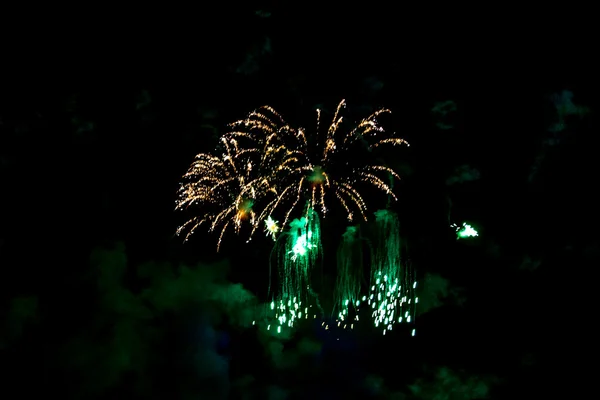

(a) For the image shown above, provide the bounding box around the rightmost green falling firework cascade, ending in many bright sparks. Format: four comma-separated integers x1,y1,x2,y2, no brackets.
367,210,419,336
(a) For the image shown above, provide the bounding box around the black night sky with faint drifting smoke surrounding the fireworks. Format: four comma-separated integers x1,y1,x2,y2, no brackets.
0,1,600,399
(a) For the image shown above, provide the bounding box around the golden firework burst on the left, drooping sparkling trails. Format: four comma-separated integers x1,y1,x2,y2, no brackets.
176,107,287,251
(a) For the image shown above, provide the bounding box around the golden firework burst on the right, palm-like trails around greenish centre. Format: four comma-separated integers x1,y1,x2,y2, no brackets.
255,100,408,233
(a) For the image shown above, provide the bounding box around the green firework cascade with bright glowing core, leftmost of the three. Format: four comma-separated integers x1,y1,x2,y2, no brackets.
267,207,321,333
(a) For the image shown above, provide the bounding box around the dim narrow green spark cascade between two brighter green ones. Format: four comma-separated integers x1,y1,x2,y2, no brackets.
335,226,366,329
